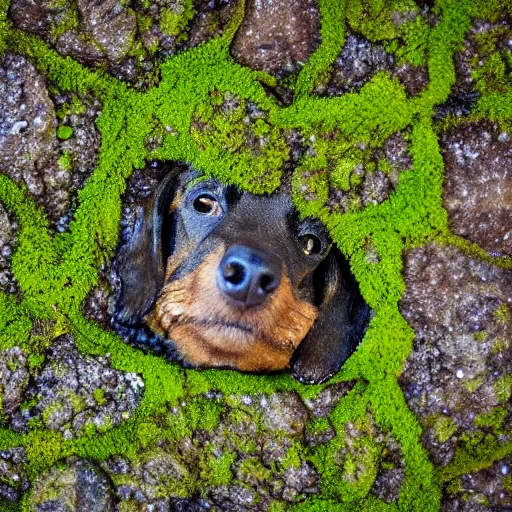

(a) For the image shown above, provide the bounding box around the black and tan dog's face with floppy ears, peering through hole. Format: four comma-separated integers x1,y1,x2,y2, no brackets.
116,168,369,382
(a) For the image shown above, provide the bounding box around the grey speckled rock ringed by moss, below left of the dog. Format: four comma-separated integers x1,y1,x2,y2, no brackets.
12,335,144,439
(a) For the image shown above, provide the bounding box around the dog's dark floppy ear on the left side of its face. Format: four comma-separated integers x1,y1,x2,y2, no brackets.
114,170,181,325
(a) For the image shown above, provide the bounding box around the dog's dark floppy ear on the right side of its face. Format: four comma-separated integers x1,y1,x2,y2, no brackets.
290,247,370,384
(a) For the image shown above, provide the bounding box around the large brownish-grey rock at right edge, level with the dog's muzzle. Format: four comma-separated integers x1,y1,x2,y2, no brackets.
400,245,512,465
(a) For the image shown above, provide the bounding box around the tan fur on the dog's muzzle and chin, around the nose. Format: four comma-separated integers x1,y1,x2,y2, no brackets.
148,247,318,371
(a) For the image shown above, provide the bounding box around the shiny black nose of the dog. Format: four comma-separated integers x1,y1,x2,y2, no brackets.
217,245,281,308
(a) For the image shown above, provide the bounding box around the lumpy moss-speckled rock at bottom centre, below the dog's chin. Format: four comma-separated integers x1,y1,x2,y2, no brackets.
102,393,320,511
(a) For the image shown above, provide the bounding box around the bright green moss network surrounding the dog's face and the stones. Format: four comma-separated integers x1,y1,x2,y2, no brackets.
0,0,512,511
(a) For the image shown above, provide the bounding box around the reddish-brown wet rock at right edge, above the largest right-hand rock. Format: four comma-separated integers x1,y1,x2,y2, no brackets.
440,122,512,255
